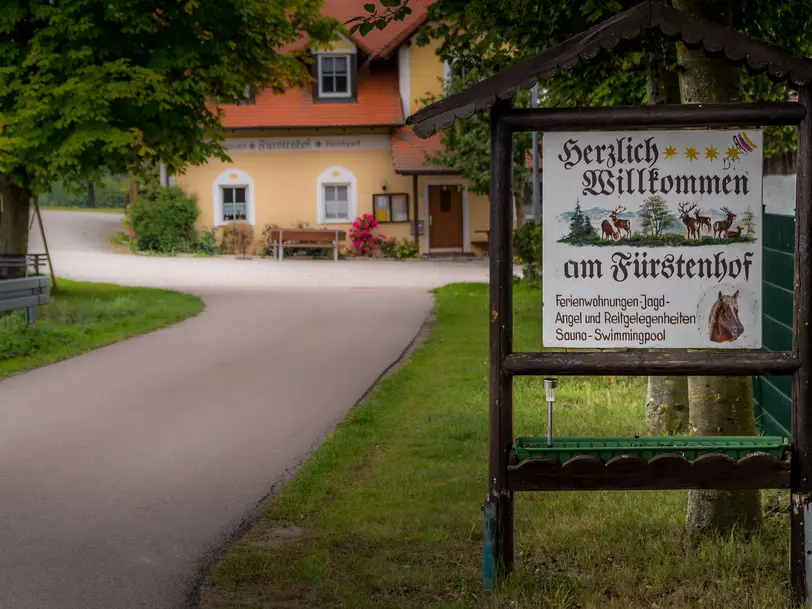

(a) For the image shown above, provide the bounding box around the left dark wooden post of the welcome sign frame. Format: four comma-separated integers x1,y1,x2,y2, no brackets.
485,95,513,588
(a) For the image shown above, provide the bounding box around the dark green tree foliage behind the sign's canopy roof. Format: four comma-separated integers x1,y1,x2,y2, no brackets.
358,0,812,155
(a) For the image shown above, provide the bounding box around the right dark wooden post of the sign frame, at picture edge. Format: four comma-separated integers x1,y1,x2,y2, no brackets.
790,86,812,604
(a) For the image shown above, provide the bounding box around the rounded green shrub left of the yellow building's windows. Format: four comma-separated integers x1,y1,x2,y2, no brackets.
133,186,200,254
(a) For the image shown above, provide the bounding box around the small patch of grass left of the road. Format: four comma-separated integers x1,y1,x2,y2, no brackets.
0,279,203,379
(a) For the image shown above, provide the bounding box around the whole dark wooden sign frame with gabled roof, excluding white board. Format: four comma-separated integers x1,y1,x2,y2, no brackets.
408,0,812,604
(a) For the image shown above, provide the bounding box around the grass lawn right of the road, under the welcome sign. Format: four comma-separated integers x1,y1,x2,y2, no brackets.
202,284,789,609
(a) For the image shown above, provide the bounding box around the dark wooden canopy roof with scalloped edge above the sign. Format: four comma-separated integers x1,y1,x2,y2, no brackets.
407,0,812,138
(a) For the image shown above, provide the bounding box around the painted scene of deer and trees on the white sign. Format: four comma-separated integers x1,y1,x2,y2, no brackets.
558,195,756,247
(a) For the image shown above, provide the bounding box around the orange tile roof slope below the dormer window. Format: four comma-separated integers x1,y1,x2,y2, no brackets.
221,68,402,130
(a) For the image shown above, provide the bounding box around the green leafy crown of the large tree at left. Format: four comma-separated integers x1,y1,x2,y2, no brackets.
0,0,339,266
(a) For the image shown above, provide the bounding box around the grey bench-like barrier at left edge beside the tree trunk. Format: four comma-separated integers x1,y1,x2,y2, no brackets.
0,254,51,323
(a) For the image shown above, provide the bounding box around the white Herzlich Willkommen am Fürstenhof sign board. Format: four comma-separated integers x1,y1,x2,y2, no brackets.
543,130,763,349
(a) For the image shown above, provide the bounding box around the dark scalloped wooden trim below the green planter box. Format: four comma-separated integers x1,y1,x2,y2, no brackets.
508,453,790,491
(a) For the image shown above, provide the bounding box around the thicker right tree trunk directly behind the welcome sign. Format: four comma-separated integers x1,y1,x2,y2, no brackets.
674,0,761,534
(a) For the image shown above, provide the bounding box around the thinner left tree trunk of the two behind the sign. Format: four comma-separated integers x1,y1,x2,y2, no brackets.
646,47,688,436
